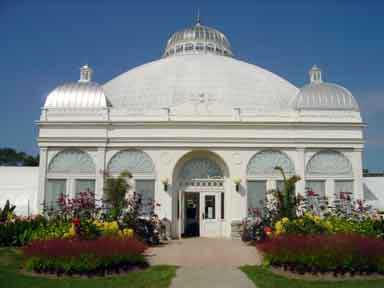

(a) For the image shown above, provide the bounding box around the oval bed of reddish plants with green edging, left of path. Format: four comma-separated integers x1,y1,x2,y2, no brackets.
23,238,148,276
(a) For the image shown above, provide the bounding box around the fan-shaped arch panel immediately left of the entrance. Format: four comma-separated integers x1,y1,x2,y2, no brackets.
108,150,155,176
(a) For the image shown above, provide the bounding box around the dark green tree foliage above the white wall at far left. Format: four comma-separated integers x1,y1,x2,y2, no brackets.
0,148,39,166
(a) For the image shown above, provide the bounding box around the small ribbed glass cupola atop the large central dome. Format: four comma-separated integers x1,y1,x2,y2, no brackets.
163,20,233,57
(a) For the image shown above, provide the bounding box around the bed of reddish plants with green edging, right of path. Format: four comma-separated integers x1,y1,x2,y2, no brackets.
256,234,384,275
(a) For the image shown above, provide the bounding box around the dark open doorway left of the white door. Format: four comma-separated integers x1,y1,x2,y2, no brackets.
183,192,200,237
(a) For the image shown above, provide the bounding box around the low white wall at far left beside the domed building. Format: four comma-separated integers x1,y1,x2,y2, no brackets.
0,167,39,215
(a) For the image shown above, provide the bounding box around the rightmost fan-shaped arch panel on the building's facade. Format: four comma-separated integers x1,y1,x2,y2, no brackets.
306,150,353,177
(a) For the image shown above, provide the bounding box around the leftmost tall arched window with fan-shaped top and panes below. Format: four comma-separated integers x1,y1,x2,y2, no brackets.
44,149,96,209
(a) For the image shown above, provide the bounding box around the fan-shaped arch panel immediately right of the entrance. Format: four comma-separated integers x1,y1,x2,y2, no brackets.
247,150,295,177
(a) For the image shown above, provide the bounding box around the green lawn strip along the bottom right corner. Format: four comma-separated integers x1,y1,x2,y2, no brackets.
240,266,384,288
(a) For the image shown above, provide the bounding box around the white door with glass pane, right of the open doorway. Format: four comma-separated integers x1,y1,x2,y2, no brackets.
200,192,220,237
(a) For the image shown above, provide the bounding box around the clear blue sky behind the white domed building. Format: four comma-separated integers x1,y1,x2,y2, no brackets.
0,0,384,170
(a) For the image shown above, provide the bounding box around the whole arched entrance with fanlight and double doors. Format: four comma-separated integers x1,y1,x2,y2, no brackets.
172,151,228,237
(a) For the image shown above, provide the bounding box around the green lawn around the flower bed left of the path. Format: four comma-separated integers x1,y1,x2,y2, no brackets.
0,248,176,288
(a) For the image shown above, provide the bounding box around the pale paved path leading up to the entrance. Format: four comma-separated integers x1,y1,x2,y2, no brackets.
148,238,261,288
